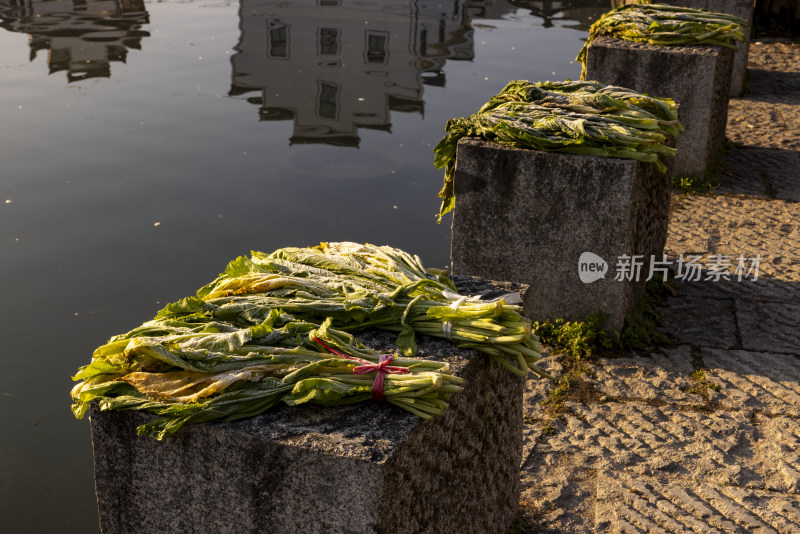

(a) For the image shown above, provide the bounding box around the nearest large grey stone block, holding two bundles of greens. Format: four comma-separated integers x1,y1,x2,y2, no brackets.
90,280,524,534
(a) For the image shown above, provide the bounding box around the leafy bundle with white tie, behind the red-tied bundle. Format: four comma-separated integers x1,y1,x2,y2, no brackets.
193,243,544,382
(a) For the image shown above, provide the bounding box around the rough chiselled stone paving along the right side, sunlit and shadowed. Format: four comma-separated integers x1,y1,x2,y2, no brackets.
520,42,800,533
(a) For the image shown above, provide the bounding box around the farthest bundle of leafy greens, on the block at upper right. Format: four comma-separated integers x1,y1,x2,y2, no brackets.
576,3,747,79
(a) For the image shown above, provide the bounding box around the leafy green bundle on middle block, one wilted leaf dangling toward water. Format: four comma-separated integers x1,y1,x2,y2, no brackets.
434,80,683,222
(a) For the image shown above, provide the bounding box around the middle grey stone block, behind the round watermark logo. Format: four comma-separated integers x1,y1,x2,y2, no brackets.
451,139,671,329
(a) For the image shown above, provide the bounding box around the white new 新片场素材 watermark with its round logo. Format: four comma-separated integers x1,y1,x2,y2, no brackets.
578,252,761,284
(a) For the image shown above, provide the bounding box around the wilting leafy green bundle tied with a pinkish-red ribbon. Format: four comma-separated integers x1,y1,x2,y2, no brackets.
71,313,463,440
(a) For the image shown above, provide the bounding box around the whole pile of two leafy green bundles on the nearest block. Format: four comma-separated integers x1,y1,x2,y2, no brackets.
71,243,547,439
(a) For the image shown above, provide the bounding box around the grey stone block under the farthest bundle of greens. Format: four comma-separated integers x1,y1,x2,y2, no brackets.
586,37,733,180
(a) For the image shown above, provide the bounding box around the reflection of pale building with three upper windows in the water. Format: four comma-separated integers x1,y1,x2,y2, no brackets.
230,0,474,146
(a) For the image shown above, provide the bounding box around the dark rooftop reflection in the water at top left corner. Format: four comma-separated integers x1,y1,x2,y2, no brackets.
0,0,150,82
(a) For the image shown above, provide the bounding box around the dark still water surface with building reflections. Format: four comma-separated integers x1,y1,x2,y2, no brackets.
0,0,608,533
